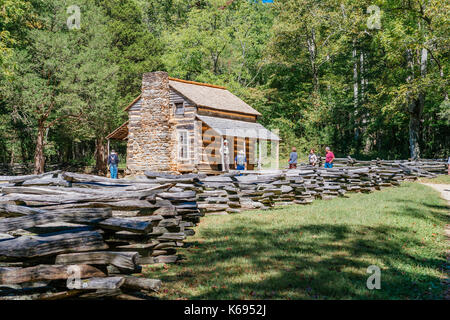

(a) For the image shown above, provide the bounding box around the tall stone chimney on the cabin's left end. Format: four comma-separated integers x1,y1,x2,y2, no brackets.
127,71,177,175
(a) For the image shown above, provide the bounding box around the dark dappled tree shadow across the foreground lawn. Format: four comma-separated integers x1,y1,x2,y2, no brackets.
156,221,445,299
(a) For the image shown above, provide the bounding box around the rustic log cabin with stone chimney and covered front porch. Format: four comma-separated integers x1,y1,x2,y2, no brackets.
107,71,280,175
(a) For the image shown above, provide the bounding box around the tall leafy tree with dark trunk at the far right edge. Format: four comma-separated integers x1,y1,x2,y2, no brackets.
380,0,449,158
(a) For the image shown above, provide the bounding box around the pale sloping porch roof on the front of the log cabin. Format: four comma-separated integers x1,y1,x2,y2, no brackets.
197,115,281,141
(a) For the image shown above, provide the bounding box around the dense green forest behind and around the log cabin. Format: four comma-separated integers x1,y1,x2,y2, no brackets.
0,0,450,173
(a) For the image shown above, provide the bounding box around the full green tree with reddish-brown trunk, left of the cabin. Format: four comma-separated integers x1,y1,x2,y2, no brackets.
3,0,115,173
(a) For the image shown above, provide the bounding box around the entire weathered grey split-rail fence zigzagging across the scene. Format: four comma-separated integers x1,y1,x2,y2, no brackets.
0,160,446,299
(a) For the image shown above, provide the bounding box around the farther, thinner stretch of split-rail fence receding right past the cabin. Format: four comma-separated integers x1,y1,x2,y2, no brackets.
197,159,447,215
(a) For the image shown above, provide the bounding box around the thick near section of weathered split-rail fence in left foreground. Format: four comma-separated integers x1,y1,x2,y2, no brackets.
0,171,201,300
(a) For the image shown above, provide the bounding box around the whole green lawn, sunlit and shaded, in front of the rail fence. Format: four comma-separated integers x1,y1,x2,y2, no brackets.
143,183,449,299
